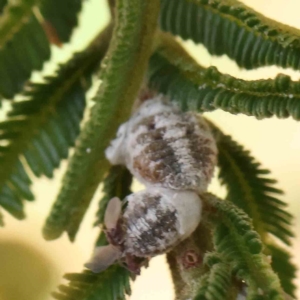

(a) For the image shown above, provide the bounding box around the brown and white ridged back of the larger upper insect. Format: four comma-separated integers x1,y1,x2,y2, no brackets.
132,108,216,189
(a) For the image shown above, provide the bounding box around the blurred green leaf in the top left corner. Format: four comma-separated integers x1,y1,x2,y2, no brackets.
0,0,50,98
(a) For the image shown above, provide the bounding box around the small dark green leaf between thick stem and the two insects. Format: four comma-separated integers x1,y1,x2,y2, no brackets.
95,166,132,225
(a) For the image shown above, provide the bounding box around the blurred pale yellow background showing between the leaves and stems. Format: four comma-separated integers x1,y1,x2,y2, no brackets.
0,0,300,300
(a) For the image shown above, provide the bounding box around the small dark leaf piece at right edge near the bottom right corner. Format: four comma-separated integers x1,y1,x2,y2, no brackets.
267,244,297,297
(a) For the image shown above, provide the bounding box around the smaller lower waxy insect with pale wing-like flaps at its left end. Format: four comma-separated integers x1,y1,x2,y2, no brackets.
85,188,202,274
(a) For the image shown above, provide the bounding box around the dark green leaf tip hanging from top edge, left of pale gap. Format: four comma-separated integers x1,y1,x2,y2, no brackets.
41,0,83,43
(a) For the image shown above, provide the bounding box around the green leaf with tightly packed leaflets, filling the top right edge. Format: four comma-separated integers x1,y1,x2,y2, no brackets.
160,0,300,70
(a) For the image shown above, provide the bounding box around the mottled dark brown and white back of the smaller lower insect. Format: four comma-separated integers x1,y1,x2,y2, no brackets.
124,192,179,257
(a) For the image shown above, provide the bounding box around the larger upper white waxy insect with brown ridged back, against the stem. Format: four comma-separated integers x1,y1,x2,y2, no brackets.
106,96,217,192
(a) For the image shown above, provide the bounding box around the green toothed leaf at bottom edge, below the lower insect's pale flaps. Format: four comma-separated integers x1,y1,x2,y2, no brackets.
53,266,130,300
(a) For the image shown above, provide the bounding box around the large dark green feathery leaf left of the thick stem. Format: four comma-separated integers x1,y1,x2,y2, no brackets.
0,30,107,219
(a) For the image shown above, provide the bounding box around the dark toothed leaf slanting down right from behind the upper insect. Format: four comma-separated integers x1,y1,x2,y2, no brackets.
213,127,293,245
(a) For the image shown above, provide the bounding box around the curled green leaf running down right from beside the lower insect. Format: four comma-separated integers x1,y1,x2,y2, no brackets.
205,194,283,300
